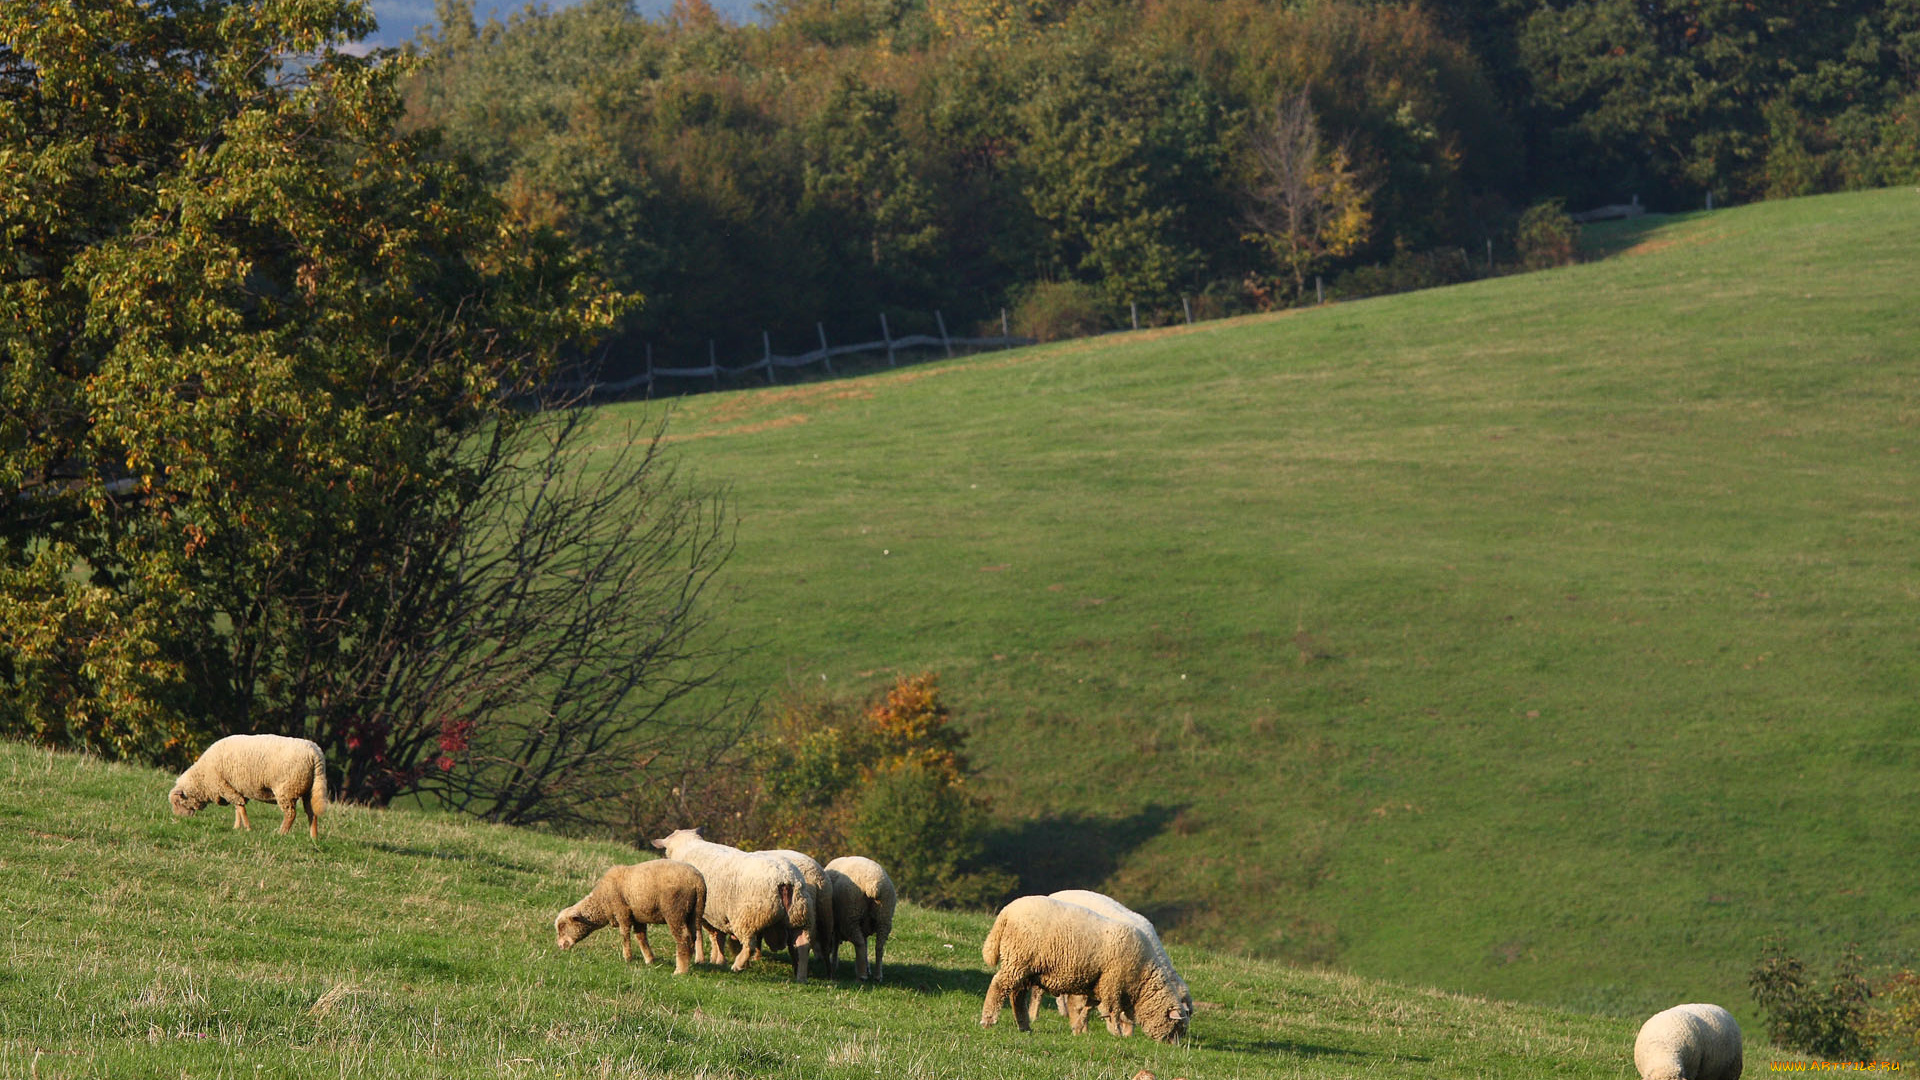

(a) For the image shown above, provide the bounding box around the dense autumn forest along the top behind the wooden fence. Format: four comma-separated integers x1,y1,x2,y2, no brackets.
409,0,1920,369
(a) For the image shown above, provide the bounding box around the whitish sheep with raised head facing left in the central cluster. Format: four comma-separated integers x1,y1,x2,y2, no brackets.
653,828,814,982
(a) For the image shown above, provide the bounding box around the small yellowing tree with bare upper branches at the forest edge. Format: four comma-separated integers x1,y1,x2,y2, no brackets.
1246,90,1373,296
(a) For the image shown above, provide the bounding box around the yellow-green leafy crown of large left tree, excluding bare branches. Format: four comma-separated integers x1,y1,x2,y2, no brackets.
0,0,624,798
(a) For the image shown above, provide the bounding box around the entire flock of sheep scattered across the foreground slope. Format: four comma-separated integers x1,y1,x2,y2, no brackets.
167,734,1741,1080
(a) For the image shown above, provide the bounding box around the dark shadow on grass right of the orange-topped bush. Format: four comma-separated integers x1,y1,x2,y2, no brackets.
987,803,1185,894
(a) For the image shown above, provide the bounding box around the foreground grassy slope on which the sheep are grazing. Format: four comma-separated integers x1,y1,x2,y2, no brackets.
0,744,1697,1080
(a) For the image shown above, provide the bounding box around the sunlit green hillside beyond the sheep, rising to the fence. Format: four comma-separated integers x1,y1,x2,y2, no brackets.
607,190,1920,1022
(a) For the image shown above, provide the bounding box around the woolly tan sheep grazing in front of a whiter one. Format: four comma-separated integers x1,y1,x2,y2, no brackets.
979,896,1190,1042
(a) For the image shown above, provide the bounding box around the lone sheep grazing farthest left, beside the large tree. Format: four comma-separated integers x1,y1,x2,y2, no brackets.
167,734,326,840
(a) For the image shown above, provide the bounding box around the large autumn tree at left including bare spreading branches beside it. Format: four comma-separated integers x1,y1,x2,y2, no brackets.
0,0,744,821
